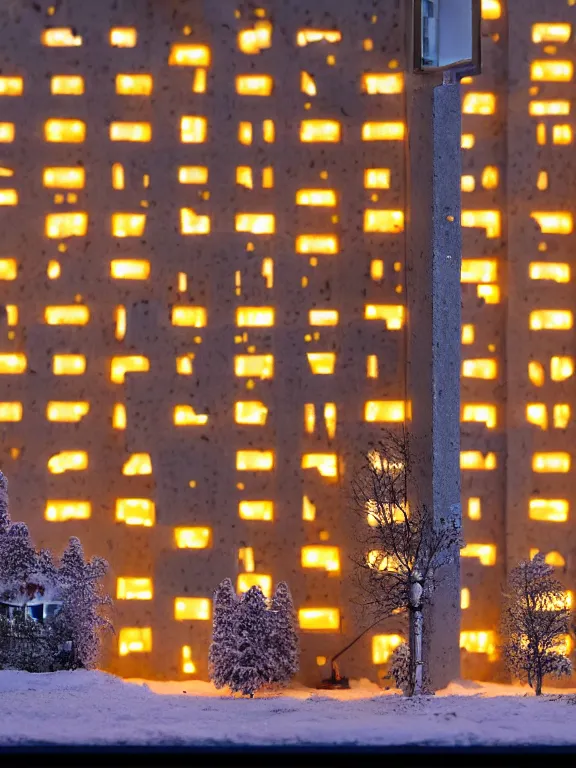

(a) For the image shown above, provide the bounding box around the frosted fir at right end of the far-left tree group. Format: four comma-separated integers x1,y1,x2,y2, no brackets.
58,536,112,669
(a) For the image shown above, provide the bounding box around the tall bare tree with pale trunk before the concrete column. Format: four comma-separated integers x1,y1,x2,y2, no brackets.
352,430,462,696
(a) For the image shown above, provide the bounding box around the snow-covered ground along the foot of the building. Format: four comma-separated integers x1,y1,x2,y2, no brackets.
0,670,576,746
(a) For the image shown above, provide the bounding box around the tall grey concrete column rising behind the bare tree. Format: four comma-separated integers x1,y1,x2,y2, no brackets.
406,81,462,689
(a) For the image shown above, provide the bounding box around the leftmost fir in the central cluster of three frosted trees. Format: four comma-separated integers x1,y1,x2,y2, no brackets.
208,579,239,688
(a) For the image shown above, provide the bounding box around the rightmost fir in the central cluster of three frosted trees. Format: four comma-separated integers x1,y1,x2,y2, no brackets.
268,581,300,685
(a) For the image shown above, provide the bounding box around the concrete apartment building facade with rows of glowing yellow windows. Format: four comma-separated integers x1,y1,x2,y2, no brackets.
0,0,576,683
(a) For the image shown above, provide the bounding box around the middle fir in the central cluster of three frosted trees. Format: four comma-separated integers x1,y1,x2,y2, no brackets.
229,586,274,698
